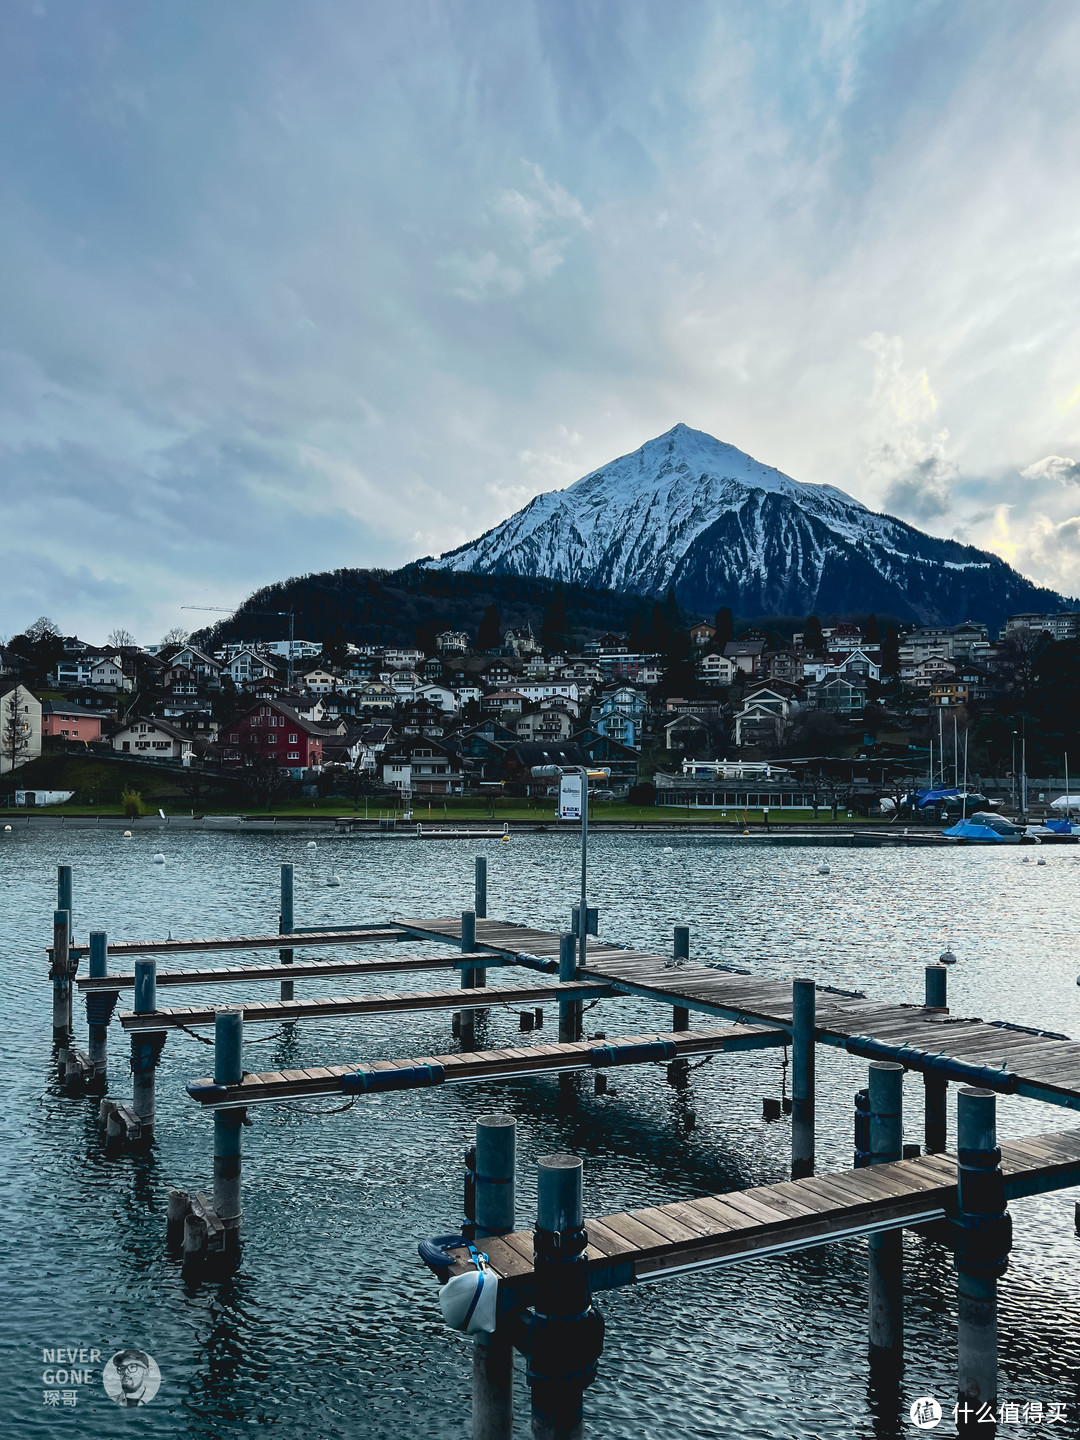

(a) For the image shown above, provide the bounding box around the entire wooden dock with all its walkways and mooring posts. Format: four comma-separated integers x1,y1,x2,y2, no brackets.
40,857,1080,1440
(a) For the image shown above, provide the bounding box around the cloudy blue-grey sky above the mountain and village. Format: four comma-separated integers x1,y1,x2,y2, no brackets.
0,0,1080,644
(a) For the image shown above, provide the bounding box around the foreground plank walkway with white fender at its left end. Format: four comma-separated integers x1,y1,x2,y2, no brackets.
437,1130,1080,1303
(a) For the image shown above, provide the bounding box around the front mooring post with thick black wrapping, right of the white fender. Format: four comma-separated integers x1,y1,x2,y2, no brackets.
528,1155,603,1440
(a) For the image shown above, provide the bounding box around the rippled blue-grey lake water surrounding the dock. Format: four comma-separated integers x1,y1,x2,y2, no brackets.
0,828,1080,1440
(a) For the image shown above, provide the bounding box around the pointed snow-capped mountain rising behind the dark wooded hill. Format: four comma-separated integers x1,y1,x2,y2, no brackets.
434,425,1074,625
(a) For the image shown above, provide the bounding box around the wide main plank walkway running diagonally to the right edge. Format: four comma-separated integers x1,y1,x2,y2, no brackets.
400,916,1080,1110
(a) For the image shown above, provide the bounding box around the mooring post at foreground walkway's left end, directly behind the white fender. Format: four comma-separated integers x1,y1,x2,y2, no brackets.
472,1113,517,1440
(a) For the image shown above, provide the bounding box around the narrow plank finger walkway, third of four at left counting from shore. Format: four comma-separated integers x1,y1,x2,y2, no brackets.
118,984,611,1031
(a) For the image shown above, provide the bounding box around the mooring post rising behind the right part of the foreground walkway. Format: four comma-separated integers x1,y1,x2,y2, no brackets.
867,1060,904,1367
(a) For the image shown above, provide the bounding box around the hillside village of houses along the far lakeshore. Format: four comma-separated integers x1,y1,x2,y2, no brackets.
0,611,1080,811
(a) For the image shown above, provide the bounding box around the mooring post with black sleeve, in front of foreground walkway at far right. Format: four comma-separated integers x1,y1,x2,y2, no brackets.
956,1086,1012,1434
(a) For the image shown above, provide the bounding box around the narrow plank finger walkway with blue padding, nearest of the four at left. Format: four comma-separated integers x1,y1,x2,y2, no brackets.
187,1019,786,1109
